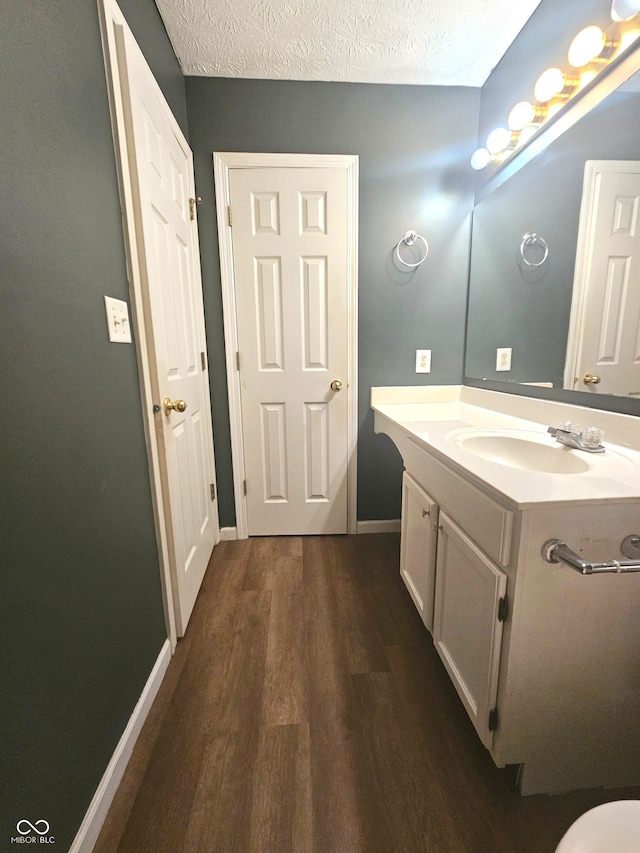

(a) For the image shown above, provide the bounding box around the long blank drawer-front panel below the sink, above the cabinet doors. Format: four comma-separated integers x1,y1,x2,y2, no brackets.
404,440,513,566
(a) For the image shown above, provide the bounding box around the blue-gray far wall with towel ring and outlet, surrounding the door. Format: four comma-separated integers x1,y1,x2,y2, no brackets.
186,77,479,526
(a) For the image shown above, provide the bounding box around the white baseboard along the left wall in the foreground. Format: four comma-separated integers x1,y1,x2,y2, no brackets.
69,639,171,853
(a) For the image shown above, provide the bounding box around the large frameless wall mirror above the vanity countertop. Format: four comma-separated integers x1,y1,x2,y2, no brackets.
465,50,640,414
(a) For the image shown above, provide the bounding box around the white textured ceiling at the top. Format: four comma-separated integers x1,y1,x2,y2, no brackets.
156,0,540,86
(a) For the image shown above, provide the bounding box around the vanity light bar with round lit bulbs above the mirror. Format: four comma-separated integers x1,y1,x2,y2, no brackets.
471,0,640,171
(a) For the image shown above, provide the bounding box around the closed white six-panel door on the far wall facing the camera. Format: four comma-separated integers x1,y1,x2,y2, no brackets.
229,167,349,535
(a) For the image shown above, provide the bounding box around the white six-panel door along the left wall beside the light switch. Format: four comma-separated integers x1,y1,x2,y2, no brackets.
116,20,220,635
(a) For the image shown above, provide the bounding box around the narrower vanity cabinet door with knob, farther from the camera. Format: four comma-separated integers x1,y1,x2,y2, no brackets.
400,472,438,632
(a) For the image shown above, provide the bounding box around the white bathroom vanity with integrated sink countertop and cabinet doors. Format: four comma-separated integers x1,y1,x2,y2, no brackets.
371,386,640,794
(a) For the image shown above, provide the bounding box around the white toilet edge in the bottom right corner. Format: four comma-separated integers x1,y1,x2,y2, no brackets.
556,800,640,853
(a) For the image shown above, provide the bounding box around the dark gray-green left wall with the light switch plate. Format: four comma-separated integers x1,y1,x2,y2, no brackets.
0,0,186,850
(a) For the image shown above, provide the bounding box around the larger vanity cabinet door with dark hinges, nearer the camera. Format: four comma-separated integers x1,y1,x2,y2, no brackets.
433,513,507,747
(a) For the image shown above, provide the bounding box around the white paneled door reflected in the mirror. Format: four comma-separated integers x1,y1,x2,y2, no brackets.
565,161,640,397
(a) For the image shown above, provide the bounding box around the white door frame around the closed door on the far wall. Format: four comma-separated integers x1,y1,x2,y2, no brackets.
213,152,358,539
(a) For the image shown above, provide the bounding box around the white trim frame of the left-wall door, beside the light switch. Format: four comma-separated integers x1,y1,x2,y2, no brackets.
98,0,211,654
